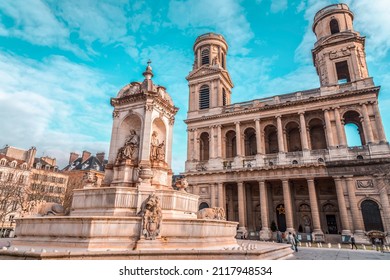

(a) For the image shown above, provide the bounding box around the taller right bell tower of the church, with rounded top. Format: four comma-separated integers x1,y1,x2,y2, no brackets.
312,4,372,87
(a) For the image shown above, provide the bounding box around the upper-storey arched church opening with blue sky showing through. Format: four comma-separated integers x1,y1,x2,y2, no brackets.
344,111,365,147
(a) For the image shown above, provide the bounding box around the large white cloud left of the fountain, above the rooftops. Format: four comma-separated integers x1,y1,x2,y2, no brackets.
0,53,115,166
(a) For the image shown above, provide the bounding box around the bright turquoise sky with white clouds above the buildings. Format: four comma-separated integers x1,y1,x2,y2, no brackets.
0,0,390,173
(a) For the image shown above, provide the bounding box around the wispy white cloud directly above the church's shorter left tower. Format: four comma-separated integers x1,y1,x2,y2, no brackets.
168,0,253,53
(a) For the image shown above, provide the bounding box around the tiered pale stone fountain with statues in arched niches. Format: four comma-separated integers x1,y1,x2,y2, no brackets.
0,62,291,259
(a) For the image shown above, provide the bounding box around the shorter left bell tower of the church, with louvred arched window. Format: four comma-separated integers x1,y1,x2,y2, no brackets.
186,33,233,117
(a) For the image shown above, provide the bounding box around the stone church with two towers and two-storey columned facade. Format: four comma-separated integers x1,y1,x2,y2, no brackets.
185,4,390,242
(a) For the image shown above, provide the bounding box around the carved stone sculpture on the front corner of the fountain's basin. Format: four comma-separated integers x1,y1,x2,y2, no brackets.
142,193,162,240
